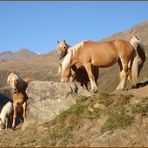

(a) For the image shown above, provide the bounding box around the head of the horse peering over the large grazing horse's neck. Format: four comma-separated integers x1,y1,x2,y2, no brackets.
57,40,69,60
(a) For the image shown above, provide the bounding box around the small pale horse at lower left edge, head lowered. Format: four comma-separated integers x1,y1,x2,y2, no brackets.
0,101,13,130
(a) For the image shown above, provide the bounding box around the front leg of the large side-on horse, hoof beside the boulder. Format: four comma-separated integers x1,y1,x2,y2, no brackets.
84,63,98,92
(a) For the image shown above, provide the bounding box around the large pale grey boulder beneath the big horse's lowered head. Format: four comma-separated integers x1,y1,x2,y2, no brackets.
27,81,91,124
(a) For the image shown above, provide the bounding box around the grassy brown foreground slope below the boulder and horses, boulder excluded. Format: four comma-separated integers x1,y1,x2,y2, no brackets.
0,86,148,147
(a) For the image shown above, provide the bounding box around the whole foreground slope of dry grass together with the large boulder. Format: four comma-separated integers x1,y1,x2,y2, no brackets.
0,81,148,147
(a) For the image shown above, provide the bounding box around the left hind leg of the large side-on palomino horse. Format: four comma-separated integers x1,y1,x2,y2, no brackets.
116,59,128,90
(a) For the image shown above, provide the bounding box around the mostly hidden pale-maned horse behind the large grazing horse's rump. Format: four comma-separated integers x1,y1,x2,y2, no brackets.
128,36,145,87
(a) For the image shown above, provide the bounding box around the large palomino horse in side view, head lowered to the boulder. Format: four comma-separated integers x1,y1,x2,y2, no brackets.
61,39,145,92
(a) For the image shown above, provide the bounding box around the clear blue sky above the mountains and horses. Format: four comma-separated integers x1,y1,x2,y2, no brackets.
0,1,148,53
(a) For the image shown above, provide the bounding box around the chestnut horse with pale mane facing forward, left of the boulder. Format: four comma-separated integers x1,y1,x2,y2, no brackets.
7,73,31,128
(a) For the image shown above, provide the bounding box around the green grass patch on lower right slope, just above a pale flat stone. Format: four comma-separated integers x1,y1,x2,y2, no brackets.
101,106,134,132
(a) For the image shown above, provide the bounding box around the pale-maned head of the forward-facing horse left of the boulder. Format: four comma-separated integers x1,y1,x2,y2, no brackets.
7,73,21,93
